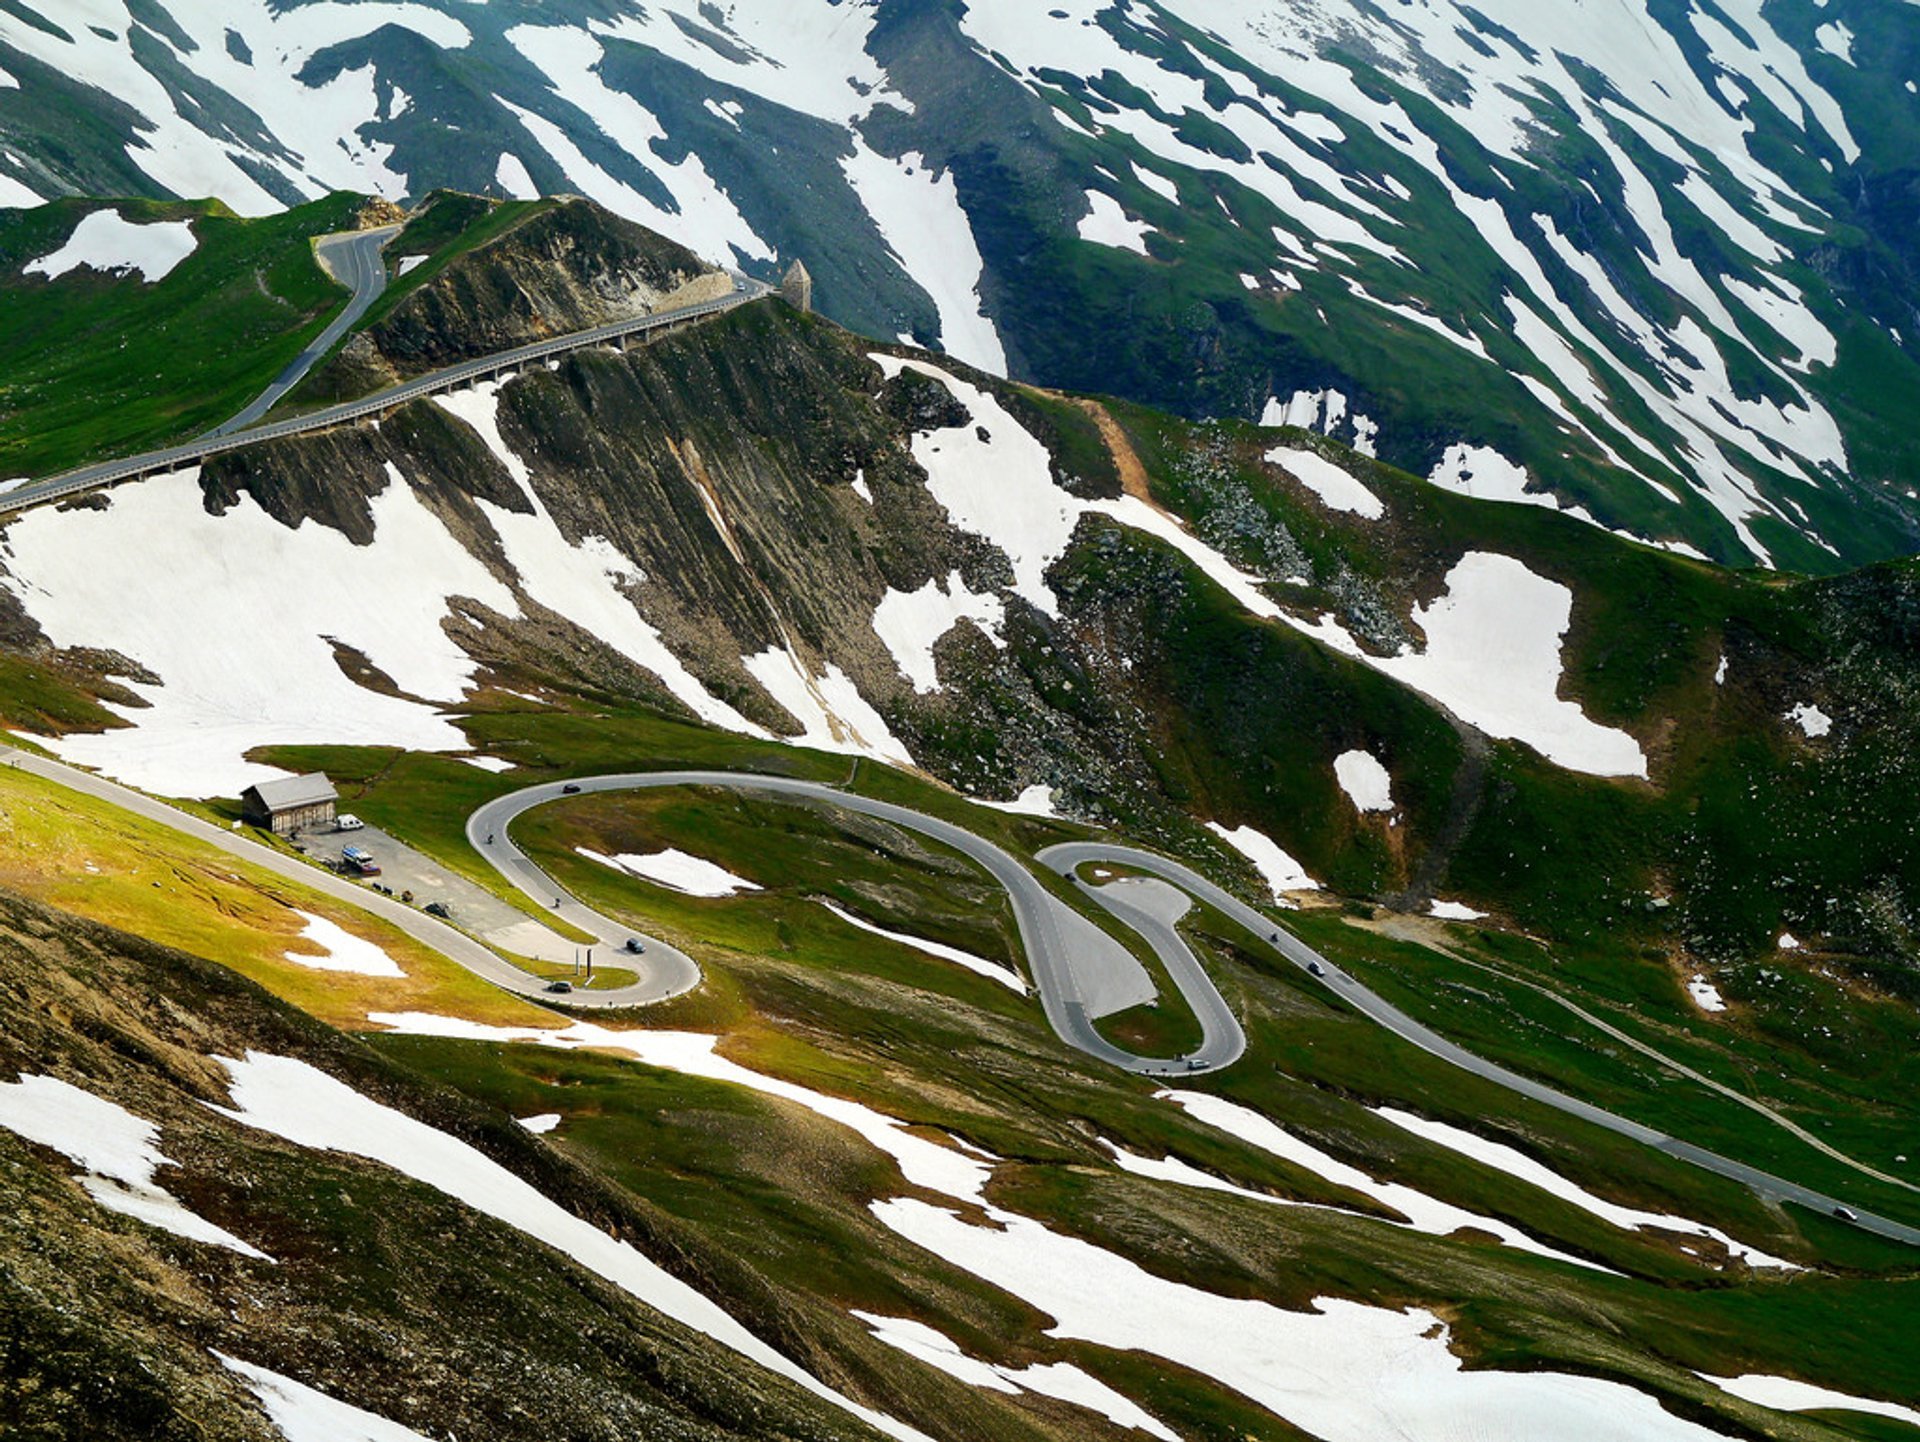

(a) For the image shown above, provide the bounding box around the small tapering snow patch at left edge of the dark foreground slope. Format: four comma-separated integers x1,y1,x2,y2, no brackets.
0,1075,273,1262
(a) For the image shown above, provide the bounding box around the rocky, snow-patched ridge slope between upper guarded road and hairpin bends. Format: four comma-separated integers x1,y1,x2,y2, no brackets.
0,282,1920,990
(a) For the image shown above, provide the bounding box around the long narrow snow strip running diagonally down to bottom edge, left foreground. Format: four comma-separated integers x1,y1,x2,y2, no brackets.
215,1039,922,1442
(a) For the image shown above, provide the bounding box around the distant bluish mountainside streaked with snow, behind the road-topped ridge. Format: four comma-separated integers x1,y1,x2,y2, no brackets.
0,0,1920,568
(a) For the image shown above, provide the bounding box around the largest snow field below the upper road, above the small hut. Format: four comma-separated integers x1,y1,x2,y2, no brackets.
4,469,503,797
